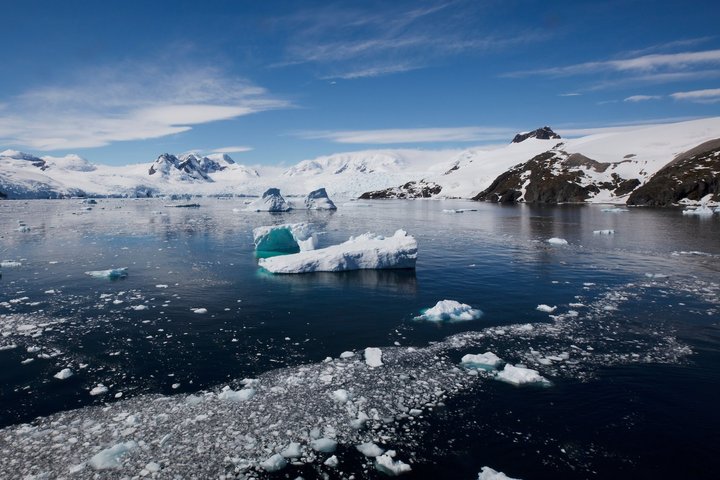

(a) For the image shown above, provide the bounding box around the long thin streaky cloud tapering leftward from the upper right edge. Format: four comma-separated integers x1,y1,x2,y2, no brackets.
504,50,720,77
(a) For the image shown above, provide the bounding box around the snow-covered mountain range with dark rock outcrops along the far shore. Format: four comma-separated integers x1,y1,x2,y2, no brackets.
0,117,720,204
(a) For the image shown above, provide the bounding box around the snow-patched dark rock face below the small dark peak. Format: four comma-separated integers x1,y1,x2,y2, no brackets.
473,148,640,204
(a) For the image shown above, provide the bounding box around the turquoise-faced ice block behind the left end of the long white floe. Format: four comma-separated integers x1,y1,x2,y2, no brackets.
253,223,317,255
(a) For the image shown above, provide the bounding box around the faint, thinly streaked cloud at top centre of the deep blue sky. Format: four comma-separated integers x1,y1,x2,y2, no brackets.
273,0,545,79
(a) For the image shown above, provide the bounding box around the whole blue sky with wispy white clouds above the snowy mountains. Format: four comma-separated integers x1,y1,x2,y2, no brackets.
0,0,720,165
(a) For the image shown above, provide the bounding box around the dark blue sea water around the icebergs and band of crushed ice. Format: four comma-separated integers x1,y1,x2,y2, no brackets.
0,199,720,479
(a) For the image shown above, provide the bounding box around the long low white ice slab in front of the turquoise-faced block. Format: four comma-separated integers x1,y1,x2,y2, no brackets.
258,230,417,273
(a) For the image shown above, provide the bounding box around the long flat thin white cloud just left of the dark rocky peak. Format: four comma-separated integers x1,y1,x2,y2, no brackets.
295,127,517,145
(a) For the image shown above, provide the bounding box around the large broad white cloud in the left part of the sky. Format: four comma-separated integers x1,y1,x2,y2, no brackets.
0,64,290,150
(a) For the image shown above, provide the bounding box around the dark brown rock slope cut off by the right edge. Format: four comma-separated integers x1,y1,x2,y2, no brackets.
627,139,720,207
